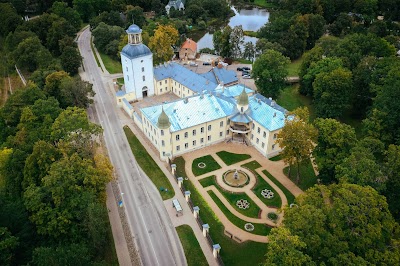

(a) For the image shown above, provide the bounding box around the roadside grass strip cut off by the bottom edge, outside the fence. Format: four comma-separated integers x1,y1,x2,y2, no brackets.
176,224,208,266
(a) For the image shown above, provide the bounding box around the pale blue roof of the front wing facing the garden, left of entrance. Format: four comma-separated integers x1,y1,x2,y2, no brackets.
141,94,236,132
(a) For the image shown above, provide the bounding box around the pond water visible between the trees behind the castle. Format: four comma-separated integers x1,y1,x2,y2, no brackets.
197,6,269,50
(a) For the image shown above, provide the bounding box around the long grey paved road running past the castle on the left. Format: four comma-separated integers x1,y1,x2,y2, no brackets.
78,28,187,266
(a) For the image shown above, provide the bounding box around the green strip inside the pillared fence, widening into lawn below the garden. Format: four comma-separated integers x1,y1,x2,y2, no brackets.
174,157,267,266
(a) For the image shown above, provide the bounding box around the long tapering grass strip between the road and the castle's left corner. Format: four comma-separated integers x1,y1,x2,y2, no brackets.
124,126,175,200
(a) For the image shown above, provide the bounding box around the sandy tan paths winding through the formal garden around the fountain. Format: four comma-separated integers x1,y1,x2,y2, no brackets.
182,142,302,243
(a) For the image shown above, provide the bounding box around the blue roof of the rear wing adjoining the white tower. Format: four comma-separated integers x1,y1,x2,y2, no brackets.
154,62,217,93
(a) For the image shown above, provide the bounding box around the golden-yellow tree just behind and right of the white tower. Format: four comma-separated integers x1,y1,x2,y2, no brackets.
149,25,179,63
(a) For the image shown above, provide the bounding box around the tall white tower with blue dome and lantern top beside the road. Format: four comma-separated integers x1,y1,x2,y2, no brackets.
121,24,154,100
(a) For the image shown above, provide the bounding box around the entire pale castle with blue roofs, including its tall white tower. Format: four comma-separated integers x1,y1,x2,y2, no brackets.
116,25,287,160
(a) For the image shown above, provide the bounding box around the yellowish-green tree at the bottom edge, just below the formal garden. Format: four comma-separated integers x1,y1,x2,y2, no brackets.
264,227,311,266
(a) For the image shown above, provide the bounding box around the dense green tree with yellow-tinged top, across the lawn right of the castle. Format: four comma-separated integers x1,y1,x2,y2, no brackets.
313,68,353,118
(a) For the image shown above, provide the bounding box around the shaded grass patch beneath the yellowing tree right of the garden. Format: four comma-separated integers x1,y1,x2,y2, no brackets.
283,160,318,190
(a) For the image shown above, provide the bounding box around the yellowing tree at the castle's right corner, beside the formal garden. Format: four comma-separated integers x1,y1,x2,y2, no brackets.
276,107,317,183
